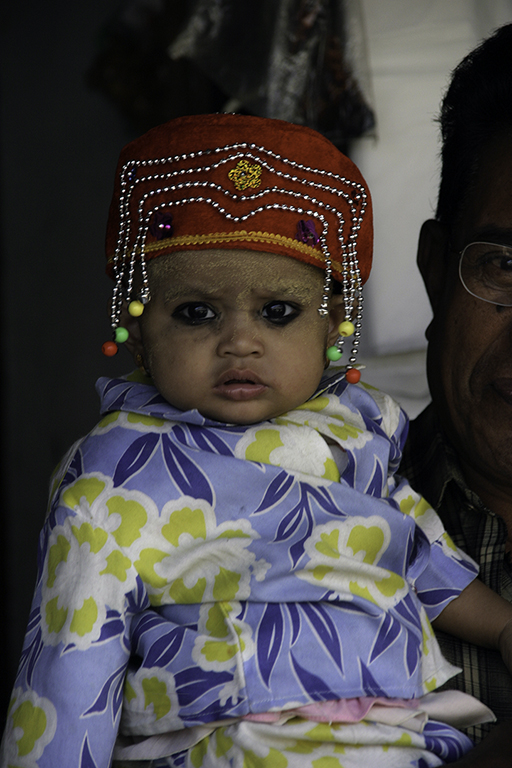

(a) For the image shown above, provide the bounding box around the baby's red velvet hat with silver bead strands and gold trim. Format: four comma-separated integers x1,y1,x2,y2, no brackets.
106,114,373,368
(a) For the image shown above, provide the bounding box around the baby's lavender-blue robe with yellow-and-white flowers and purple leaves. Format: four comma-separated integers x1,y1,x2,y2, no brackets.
2,374,476,768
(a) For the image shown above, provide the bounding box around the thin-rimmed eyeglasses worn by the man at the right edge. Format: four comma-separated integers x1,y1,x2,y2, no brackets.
459,243,512,307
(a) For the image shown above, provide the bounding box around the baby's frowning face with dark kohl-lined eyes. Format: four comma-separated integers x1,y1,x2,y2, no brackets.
136,250,336,424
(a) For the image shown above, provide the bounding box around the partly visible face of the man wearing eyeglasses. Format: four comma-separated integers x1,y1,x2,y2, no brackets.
424,130,512,487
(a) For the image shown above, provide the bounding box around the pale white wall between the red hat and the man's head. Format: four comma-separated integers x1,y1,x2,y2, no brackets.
349,0,512,354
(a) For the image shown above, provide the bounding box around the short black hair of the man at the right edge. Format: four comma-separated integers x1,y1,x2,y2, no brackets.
436,24,512,227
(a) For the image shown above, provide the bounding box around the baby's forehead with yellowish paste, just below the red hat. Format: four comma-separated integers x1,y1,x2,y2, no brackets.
148,249,323,298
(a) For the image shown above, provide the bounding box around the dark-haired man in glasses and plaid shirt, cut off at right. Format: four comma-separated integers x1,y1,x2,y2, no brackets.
400,24,512,768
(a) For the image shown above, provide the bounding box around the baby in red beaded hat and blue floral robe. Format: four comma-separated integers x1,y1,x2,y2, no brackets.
2,115,512,768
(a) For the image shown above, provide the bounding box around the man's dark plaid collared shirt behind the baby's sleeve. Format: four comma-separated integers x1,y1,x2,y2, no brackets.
399,405,512,741
